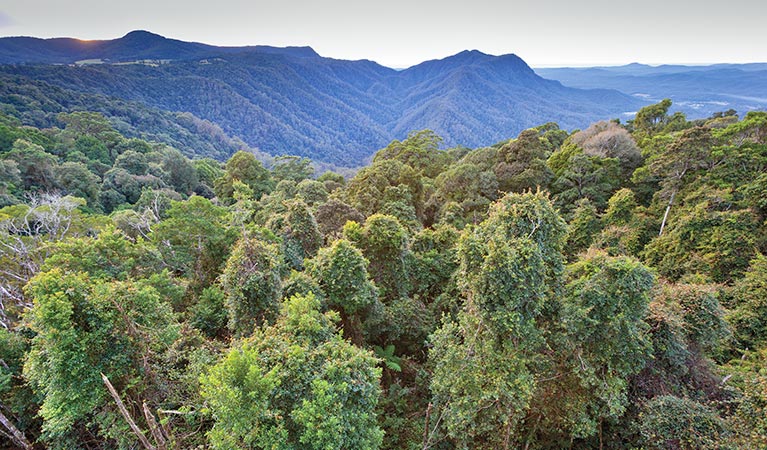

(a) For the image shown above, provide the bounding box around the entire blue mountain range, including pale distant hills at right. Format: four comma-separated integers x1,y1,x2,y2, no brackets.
6,31,767,167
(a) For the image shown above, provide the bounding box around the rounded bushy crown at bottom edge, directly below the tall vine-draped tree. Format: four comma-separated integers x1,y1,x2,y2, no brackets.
424,314,534,450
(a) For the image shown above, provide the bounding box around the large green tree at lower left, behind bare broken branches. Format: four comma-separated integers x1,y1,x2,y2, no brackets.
24,269,178,449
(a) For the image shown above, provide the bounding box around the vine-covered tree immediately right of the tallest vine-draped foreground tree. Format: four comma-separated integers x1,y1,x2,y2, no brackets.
544,251,654,446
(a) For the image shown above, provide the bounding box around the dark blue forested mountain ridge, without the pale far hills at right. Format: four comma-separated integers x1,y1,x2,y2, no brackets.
0,31,647,166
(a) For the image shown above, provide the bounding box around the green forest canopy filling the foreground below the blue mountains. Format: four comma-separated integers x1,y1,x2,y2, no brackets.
0,101,767,449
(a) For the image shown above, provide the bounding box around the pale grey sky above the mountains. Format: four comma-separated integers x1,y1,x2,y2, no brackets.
0,0,767,68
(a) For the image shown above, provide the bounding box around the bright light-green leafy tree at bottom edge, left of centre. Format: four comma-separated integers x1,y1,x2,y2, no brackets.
201,295,383,450
